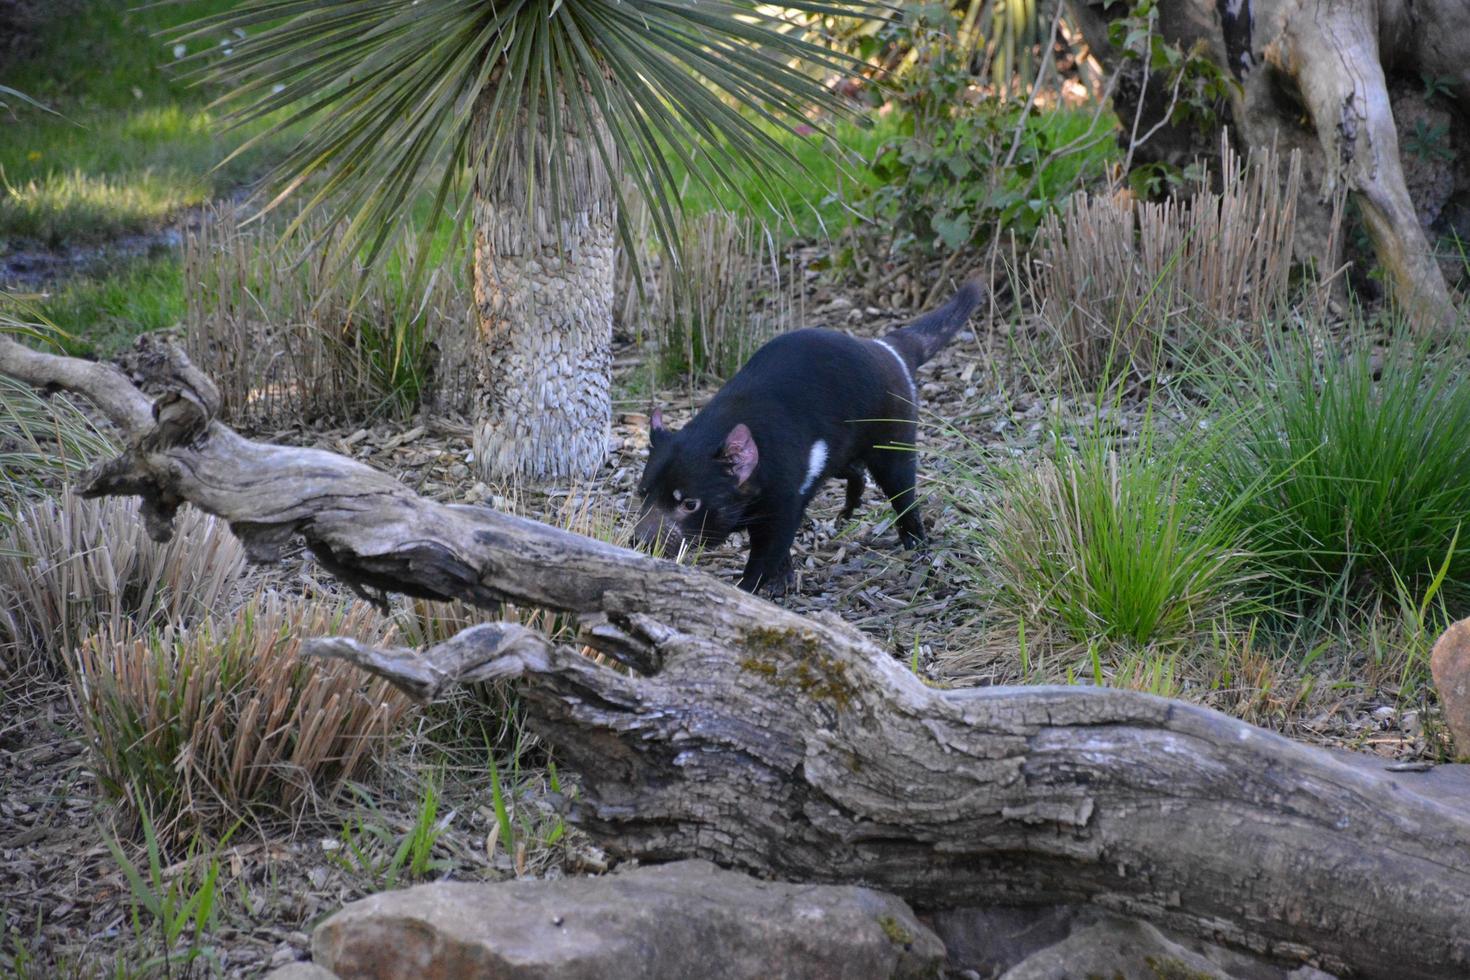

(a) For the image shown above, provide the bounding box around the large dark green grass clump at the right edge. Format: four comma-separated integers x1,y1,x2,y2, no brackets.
1200,336,1470,614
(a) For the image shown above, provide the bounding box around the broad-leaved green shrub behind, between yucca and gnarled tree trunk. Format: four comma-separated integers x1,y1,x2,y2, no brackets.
854,6,1116,270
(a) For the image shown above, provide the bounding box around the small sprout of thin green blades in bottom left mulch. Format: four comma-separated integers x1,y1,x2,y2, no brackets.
103,811,223,976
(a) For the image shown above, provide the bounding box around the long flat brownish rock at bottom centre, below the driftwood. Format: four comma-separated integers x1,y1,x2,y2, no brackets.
312,861,945,980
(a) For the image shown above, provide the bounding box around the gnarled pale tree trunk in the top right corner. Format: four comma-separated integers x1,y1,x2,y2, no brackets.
1069,0,1470,331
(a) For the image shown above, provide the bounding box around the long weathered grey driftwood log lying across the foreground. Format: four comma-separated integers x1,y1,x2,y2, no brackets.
0,338,1470,977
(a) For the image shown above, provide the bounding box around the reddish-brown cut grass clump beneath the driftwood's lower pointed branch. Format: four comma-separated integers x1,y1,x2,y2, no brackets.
72,595,409,839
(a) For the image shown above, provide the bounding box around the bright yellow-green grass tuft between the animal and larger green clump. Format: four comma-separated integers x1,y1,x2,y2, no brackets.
989,436,1251,645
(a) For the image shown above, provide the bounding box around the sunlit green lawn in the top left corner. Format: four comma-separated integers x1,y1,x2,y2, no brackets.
0,0,298,250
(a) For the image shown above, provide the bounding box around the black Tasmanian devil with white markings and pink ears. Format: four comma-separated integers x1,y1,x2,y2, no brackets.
634,282,982,595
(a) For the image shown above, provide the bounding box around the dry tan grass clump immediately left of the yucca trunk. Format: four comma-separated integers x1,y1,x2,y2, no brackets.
184,204,469,428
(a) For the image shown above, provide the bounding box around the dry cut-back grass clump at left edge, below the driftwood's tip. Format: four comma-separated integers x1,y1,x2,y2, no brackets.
0,491,245,674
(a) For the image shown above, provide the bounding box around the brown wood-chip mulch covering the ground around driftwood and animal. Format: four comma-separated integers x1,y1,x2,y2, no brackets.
0,257,1441,976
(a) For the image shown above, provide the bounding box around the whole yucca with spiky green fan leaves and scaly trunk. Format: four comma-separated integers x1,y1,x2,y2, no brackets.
177,0,878,479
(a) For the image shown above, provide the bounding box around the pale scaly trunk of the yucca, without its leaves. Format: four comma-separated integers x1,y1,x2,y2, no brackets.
473,93,616,482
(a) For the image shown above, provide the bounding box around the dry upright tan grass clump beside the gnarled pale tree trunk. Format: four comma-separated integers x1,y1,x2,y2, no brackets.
1029,144,1301,383
